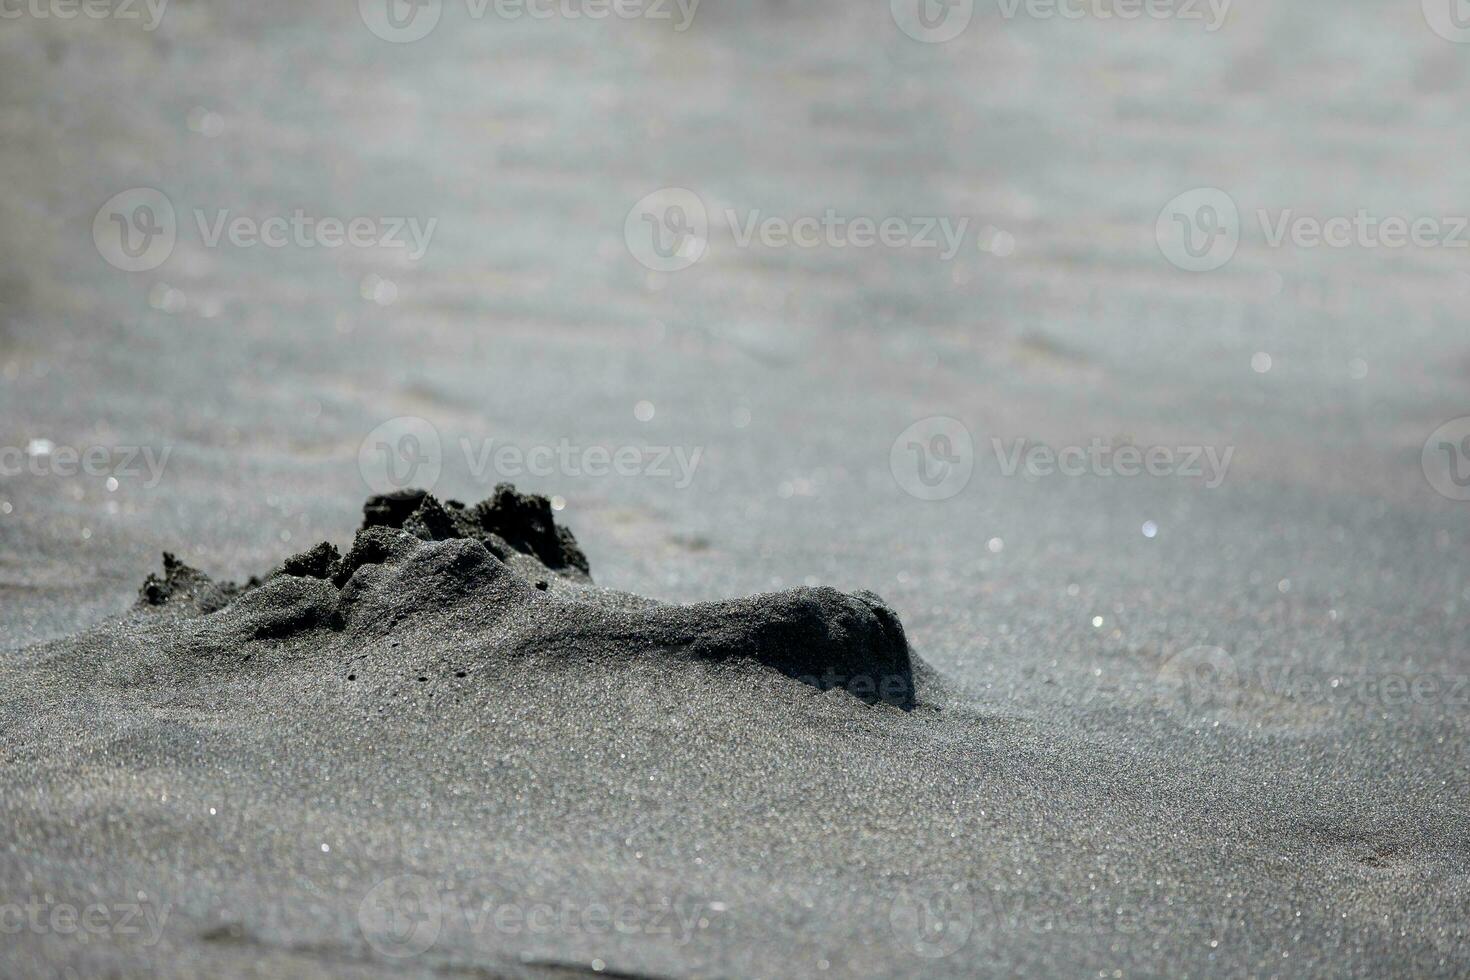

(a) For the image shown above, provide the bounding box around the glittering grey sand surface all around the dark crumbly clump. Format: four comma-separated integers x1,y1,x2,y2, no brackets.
0,0,1470,977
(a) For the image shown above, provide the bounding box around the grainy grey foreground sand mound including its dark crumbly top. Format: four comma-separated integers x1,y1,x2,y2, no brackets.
0,488,1470,980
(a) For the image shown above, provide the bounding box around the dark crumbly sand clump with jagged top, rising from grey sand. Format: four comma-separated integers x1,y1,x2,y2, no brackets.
138,483,914,708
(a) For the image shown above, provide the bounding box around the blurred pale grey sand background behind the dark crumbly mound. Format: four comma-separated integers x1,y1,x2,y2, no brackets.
0,0,1470,973
